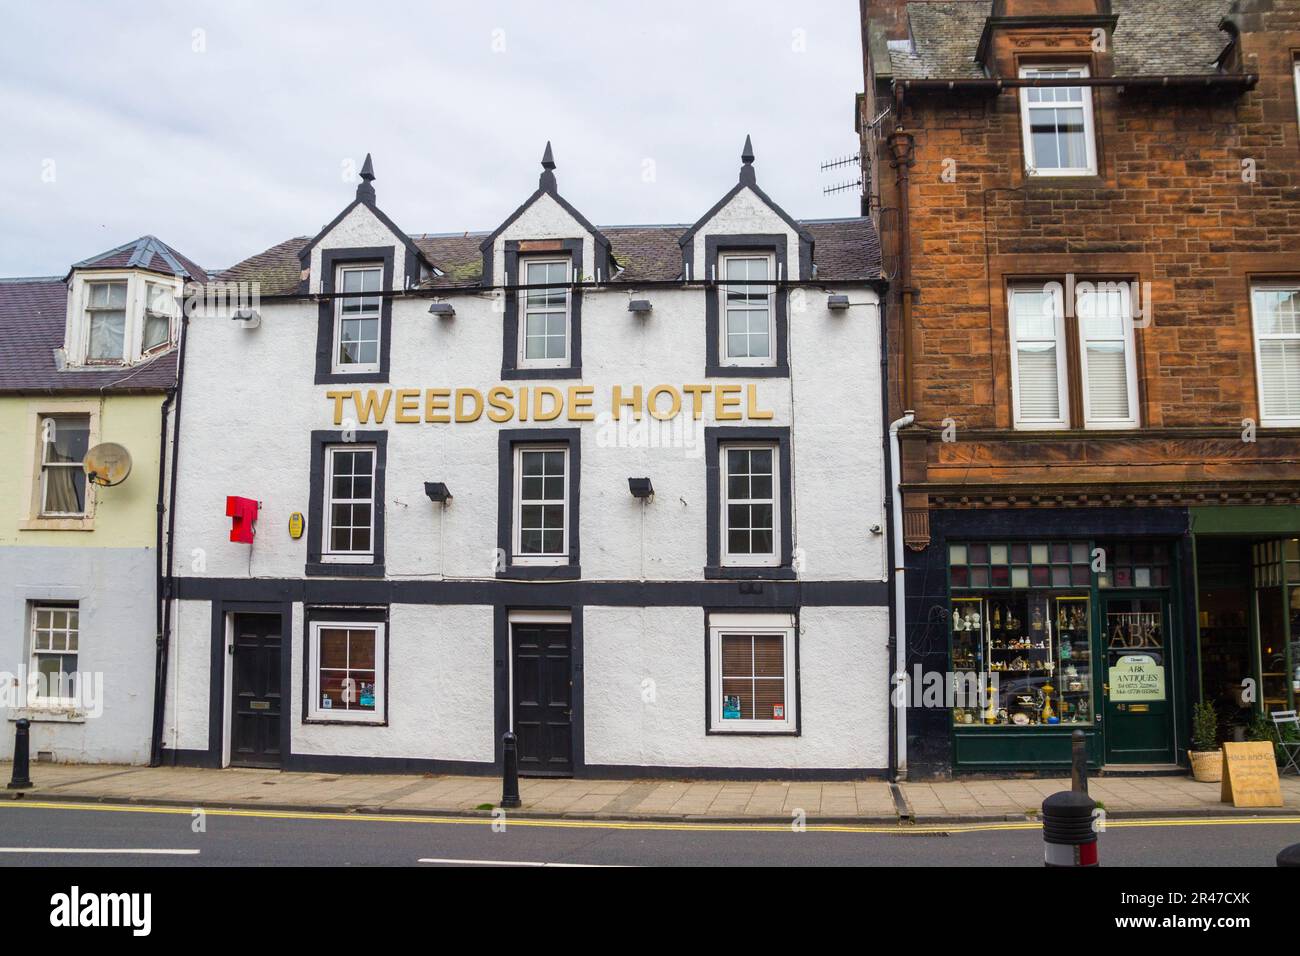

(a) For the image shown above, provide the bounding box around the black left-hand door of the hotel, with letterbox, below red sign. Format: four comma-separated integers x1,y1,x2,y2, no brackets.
230,614,281,767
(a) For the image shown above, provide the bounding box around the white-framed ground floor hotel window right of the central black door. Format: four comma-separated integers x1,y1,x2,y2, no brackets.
709,614,797,732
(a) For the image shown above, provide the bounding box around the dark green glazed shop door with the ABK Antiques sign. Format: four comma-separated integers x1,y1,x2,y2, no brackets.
1100,594,1177,763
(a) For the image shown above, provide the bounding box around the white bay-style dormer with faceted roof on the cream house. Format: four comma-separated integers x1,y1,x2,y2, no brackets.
57,235,208,369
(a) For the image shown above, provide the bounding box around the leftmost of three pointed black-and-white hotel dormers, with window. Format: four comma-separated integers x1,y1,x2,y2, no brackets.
298,153,434,385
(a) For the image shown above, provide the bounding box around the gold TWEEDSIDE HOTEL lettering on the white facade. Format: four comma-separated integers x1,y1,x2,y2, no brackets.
325,384,774,425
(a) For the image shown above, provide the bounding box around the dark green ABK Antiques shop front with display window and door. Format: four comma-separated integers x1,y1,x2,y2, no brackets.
905,507,1199,777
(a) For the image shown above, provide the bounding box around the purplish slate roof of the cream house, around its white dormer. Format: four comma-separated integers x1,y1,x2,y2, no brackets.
0,277,176,392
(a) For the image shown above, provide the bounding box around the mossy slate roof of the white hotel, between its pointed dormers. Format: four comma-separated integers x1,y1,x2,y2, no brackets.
216,219,880,295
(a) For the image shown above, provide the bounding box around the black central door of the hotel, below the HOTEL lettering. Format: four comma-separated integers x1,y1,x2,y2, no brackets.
512,624,573,777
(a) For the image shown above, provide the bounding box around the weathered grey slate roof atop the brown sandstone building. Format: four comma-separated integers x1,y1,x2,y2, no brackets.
889,0,1231,79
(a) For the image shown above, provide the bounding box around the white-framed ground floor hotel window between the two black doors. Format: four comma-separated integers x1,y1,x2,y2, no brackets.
308,620,387,723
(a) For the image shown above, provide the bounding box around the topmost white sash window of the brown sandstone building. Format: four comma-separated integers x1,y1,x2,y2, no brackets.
1021,64,1097,176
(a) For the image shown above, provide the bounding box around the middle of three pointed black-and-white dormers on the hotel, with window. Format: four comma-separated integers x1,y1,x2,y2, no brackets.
478,143,615,378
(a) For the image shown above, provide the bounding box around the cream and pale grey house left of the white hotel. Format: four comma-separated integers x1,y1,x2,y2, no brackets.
0,237,192,763
